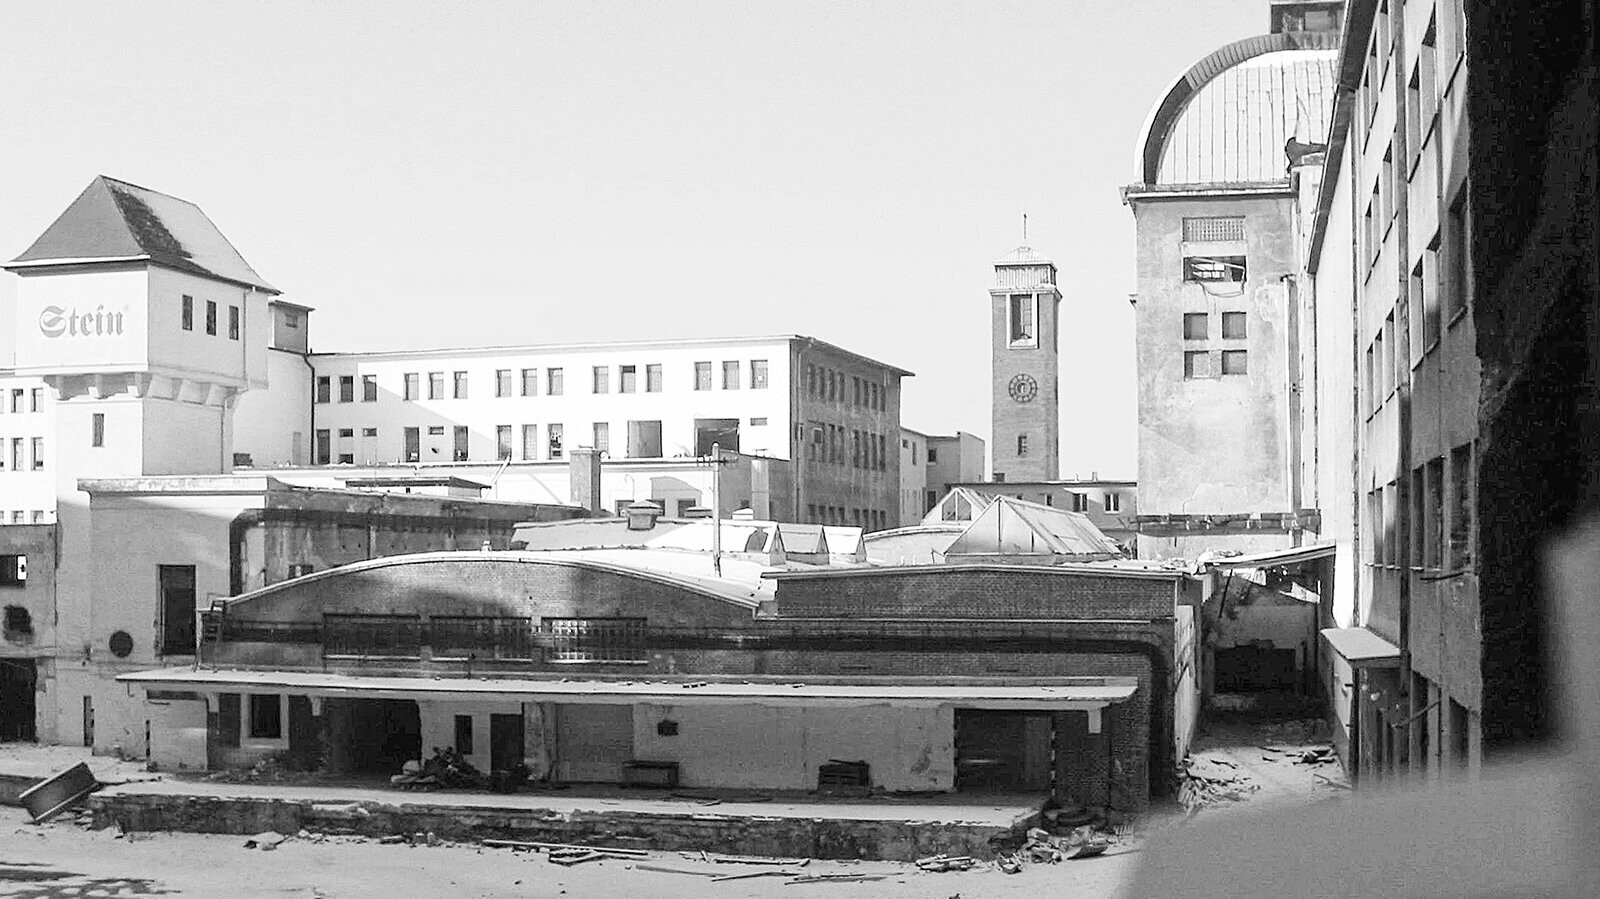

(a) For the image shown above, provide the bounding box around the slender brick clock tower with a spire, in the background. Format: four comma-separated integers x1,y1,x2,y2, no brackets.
989,246,1061,481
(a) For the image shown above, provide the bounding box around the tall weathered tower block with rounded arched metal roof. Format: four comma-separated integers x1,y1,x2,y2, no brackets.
1123,0,1341,558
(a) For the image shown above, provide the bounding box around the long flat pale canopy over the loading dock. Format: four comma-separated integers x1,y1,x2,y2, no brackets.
117,667,1139,710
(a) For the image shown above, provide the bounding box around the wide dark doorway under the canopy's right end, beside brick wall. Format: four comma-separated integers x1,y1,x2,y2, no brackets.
955,709,1051,793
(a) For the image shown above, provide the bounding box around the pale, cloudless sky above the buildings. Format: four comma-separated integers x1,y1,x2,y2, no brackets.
0,0,1267,478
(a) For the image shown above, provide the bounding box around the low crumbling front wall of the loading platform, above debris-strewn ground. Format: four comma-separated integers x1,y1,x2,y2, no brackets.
88,795,1037,861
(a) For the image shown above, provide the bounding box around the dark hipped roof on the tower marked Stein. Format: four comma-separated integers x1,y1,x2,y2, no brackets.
6,176,278,294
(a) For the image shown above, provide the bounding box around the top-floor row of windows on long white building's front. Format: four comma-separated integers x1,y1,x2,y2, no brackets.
315,358,768,403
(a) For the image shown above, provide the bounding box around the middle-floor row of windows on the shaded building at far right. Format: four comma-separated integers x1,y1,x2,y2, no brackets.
1366,443,1474,571
